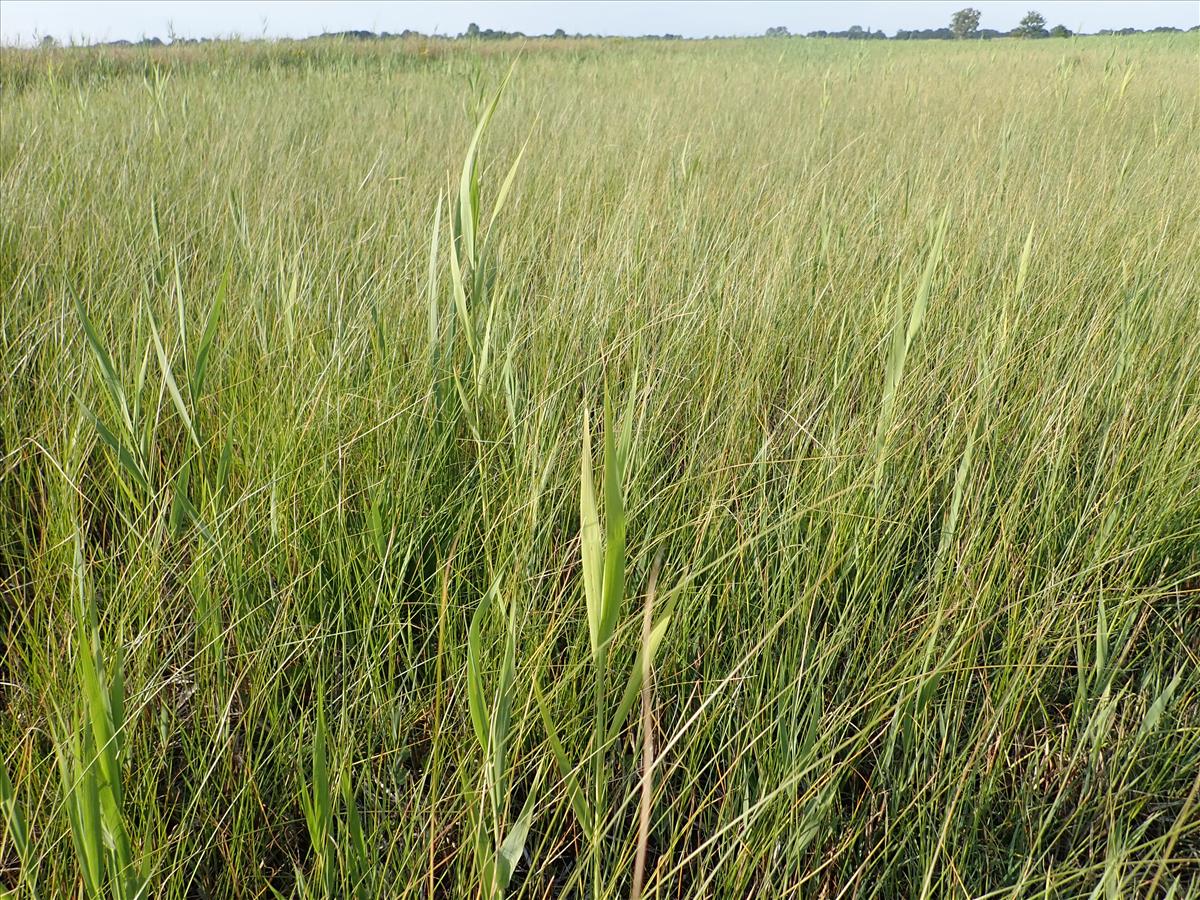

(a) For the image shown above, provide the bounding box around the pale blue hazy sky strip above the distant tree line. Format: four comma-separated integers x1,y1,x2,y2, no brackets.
0,0,1200,44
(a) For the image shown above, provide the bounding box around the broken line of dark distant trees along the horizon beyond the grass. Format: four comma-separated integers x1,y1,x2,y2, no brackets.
41,6,1200,47
